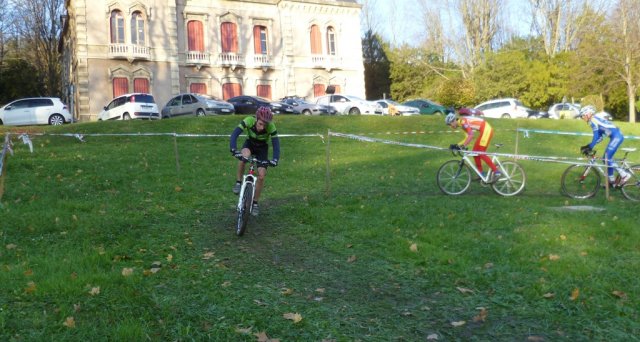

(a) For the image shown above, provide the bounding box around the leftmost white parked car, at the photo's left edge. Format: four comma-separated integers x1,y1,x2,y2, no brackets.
0,97,73,126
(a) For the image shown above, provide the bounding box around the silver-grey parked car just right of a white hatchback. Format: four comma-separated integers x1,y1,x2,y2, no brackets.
162,93,234,118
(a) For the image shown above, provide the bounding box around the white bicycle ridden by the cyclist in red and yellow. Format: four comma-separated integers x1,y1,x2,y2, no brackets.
436,144,527,196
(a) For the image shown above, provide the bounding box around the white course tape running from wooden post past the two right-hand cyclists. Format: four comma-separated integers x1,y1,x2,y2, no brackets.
329,131,634,166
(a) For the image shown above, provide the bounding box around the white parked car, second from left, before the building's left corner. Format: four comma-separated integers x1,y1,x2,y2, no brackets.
98,93,161,121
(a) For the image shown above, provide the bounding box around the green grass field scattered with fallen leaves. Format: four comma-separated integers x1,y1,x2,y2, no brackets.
0,116,640,341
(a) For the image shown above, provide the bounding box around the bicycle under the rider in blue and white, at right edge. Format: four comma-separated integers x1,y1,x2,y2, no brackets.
560,147,640,201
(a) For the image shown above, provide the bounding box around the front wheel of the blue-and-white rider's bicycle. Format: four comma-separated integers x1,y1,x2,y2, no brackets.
560,165,600,199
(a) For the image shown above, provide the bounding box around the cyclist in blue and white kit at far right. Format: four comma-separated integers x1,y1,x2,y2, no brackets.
578,106,631,186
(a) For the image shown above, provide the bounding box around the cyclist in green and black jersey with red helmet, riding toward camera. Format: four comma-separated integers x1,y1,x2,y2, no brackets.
229,107,280,216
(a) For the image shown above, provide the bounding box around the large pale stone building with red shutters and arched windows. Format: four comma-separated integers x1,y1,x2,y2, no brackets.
59,0,365,121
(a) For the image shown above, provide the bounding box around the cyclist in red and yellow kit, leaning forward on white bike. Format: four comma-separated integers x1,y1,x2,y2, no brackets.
444,111,502,183
